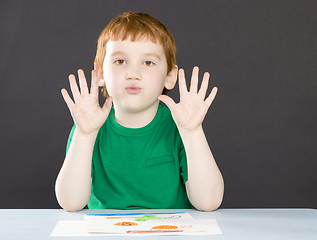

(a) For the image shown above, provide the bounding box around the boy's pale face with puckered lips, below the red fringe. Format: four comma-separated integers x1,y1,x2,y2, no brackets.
103,39,177,112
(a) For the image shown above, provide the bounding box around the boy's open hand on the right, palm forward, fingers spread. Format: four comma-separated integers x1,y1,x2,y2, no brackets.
159,67,218,132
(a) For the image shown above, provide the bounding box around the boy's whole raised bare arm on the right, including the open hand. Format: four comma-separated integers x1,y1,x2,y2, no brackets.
159,67,224,211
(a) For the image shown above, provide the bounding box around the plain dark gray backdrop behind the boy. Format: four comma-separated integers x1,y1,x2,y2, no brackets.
0,0,317,208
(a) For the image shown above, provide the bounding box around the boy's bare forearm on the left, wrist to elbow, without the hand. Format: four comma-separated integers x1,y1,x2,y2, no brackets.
55,129,96,211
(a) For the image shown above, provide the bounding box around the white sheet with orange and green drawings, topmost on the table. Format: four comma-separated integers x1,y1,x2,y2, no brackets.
85,212,205,235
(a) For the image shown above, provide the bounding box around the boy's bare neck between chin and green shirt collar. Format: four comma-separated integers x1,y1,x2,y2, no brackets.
114,102,159,128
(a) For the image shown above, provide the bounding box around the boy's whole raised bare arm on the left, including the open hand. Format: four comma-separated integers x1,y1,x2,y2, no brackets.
55,70,112,211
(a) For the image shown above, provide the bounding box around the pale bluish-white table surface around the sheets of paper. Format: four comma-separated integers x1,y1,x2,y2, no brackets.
0,209,317,240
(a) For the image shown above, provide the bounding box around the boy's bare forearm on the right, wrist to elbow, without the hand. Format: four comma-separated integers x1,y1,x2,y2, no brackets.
179,126,224,211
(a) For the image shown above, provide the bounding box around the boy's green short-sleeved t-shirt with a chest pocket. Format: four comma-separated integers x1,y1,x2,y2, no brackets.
67,104,191,209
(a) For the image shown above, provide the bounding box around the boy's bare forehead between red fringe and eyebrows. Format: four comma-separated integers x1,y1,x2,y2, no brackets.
106,39,165,58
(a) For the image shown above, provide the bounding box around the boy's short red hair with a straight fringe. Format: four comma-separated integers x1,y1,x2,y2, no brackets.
94,12,176,97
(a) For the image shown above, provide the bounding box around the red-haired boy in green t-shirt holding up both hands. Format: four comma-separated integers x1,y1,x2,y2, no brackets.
55,12,224,211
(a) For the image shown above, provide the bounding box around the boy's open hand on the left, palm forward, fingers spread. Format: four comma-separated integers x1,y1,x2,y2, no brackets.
61,69,112,135
